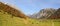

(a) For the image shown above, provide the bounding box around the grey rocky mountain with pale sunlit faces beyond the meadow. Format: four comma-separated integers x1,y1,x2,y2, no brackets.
30,8,57,19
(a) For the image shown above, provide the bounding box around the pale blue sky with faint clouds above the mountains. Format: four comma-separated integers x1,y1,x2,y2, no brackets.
0,0,60,15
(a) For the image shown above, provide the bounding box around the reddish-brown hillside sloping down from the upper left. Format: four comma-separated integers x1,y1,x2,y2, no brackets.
0,2,28,19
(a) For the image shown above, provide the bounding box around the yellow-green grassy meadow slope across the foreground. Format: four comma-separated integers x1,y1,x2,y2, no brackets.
0,11,60,26
